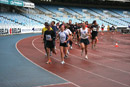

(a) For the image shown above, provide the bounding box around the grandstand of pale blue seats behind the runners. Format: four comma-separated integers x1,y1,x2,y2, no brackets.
0,0,130,34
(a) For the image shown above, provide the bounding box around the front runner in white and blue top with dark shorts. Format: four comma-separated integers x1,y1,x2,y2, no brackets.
59,24,69,64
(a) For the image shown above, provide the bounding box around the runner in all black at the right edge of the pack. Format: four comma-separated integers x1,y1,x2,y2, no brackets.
91,20,99,49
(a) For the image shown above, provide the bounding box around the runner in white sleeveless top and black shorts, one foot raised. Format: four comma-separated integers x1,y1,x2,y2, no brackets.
79,22,90,59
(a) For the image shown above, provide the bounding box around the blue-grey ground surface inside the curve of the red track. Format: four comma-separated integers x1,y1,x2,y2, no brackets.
0,34,69,87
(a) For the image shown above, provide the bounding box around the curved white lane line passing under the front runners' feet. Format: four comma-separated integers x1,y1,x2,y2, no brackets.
32,38,130,87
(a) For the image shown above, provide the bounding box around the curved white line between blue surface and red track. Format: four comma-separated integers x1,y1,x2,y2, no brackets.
15,37,80,87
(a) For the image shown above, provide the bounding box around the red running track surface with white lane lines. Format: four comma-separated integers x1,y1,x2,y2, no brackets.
17,32,130,87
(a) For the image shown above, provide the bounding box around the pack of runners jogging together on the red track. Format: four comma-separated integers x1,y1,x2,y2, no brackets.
42,20,99,64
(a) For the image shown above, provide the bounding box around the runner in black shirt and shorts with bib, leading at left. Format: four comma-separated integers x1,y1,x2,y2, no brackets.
44,24,56,64
